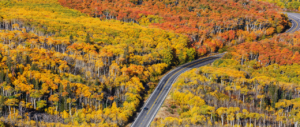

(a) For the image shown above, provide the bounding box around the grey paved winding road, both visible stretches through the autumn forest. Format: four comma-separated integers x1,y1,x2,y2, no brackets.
131,13,300,127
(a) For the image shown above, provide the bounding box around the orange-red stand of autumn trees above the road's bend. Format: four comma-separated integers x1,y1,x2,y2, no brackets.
58,0,288,55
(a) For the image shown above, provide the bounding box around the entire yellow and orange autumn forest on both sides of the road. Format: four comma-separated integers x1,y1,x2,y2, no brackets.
0,0,300,126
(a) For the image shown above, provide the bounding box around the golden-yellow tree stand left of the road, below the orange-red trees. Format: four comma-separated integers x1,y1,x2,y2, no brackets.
0,0,195,126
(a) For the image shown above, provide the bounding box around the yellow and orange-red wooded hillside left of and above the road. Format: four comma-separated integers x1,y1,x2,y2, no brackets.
0,0,288,126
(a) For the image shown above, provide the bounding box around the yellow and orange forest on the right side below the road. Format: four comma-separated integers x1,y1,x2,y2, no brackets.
151,32,300,127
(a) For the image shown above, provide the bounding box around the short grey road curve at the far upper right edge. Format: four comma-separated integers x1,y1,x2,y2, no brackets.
286,13,300,33
